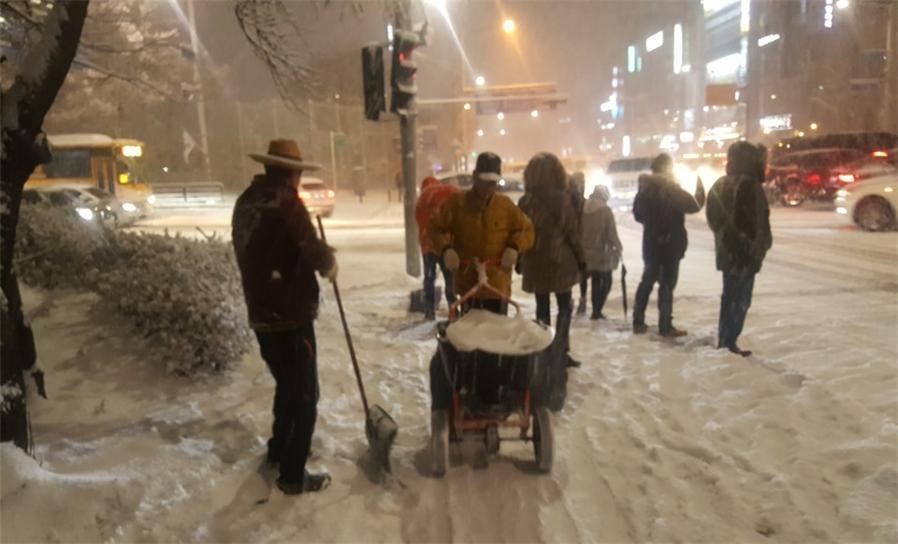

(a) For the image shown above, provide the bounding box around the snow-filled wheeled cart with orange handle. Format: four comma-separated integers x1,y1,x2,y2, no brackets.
431,262,554,477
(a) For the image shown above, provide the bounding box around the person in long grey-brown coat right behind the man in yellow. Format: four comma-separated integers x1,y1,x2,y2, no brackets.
518,153,585,367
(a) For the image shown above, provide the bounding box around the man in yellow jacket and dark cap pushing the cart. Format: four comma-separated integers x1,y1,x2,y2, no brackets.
427,151,534,314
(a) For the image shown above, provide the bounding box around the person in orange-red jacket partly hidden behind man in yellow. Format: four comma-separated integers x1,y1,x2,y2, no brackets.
415,176,459,319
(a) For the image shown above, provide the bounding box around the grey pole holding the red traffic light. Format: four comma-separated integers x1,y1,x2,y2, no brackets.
394,0,421,278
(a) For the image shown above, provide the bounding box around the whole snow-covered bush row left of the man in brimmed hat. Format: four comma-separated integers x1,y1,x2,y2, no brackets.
16,205,251,374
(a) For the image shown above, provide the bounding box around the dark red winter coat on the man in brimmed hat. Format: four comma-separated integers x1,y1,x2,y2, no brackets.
231,175,334,331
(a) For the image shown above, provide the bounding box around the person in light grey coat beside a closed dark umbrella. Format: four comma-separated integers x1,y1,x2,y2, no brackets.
580,185,623,319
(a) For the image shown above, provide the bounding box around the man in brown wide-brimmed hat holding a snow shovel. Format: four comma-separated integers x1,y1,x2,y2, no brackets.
231,140,337,495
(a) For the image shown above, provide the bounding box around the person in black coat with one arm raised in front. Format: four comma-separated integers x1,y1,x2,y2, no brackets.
633,153,705,337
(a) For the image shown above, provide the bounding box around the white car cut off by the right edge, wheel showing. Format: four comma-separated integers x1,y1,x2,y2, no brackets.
835,173,898,232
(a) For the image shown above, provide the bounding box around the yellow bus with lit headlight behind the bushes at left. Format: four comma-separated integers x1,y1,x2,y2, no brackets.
25,134,155,215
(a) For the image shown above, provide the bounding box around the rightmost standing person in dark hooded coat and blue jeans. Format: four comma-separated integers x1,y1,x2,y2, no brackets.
705,142,773,357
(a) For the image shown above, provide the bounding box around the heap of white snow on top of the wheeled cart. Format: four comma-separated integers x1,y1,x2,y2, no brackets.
446,310,555,355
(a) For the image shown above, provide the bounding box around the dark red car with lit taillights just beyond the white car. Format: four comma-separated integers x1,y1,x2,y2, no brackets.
766,148,867,206
